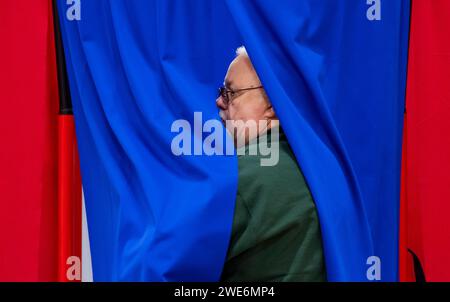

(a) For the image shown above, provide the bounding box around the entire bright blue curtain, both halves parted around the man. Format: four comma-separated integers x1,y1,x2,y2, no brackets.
58,0,409,281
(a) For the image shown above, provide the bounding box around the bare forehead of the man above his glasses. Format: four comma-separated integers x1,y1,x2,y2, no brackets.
225,55,258,88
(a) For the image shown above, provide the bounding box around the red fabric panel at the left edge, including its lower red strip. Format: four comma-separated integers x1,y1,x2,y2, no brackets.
0,0,81,281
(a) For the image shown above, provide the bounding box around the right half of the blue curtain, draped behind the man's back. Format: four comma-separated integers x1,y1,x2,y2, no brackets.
227,0,410,281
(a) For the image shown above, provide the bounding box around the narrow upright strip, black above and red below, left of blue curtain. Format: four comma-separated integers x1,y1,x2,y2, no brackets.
52,1,83,282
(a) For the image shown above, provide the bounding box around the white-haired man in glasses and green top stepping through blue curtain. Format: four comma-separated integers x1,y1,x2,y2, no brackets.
216,47,326,281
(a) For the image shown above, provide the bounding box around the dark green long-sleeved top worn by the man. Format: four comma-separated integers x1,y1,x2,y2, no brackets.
221,127,326,281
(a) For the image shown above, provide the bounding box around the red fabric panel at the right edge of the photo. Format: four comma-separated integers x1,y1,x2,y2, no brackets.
400,0,450,281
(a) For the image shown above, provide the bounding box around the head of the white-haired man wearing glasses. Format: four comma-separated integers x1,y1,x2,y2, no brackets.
216,47,278,147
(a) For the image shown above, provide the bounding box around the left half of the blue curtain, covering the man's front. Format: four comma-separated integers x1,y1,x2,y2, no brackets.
58,0,241,281
